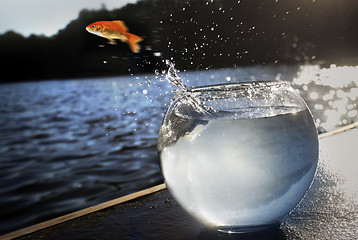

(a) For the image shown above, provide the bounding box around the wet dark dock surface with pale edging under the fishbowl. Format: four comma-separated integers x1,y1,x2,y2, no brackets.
0,123,358,240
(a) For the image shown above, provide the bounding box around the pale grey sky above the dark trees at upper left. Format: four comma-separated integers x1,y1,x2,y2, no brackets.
0,0,137,36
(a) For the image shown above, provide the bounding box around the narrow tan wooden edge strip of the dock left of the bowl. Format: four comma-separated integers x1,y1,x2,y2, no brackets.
0,183,166,240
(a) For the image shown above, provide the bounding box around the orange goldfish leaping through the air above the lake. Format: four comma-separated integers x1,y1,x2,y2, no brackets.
86,20,143,53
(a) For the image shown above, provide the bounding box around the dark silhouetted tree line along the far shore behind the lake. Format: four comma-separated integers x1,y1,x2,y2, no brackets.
0,0,358,81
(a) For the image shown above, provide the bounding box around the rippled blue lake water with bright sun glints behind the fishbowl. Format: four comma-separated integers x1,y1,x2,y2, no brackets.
0,62,358,234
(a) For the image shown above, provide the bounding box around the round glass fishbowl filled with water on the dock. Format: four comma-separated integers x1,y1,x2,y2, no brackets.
158,81,318,232
